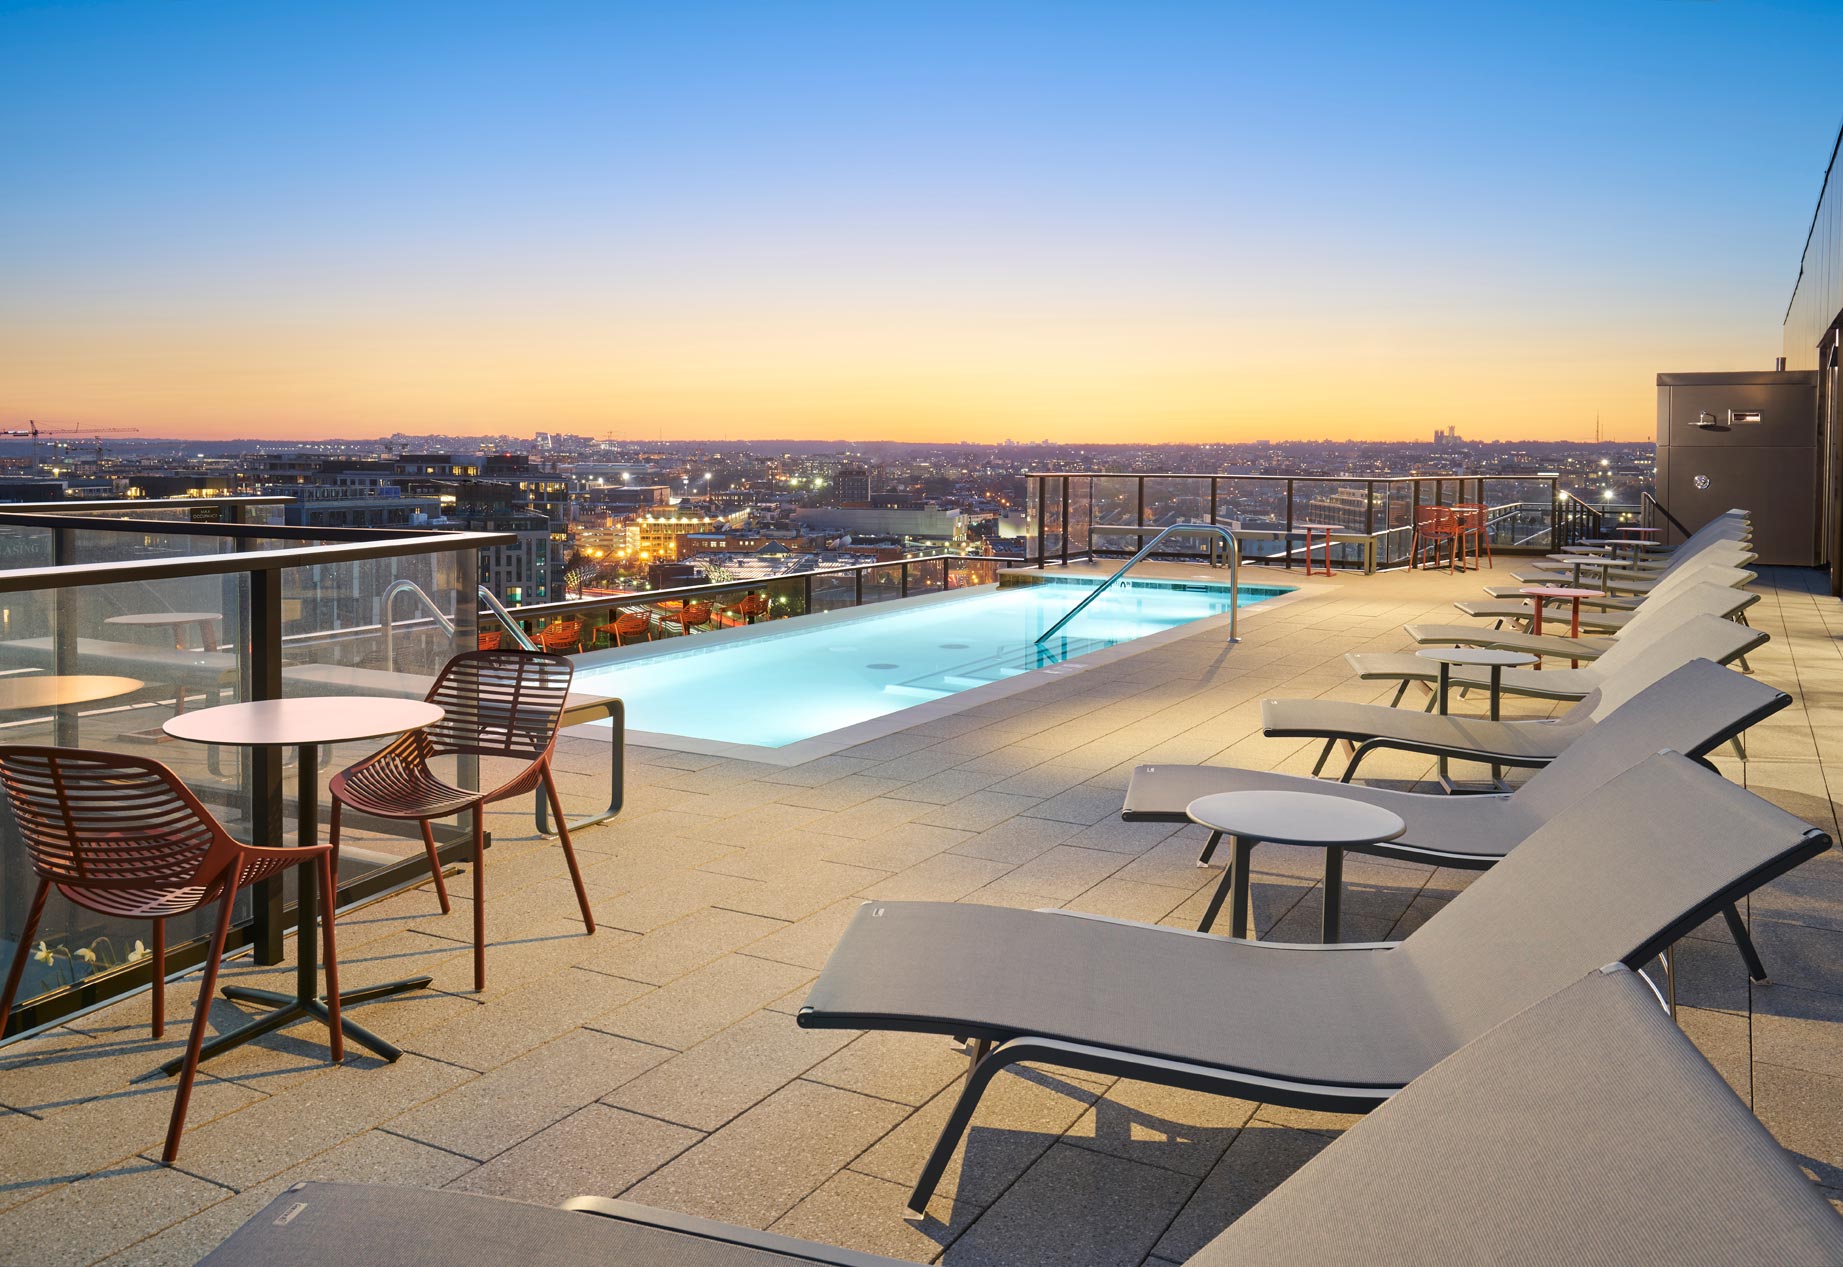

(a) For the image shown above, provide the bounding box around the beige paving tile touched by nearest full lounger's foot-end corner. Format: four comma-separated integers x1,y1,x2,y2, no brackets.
603,1011,857,1131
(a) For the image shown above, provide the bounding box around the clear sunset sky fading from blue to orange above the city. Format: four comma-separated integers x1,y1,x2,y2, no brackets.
0,0,1843,441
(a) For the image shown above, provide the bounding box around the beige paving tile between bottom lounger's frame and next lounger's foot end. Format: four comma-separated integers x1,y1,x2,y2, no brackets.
623,1083,907,1228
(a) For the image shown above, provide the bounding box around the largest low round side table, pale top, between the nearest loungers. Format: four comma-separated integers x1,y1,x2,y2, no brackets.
1185,791,1408,942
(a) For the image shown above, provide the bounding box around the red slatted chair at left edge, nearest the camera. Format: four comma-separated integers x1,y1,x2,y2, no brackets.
0,745,345,1166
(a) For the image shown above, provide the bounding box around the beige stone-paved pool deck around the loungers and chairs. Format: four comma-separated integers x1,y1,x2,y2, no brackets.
0,568,1843,1267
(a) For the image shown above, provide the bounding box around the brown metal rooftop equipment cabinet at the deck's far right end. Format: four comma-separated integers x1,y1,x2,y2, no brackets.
1657,369,1826,568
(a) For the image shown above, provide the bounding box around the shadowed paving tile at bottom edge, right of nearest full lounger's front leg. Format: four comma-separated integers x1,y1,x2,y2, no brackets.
951,1143,1196,1267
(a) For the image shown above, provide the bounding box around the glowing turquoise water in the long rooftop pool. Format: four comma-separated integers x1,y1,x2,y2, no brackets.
575,579,1290,747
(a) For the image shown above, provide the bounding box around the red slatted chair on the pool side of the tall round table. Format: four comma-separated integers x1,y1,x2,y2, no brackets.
328,651,595,990
